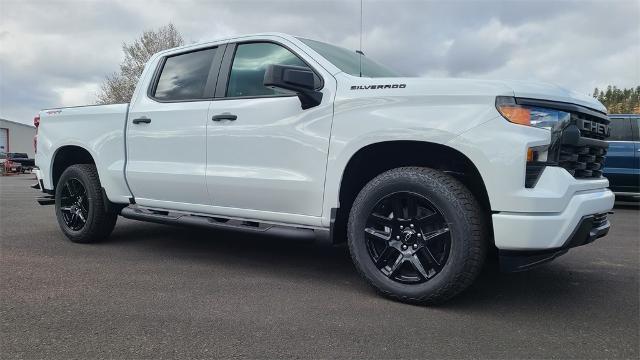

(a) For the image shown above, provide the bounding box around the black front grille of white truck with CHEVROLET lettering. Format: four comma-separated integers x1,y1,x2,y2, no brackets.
558,113,609,179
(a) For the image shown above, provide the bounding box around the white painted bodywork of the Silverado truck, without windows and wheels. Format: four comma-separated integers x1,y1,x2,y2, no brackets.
36,34,613,249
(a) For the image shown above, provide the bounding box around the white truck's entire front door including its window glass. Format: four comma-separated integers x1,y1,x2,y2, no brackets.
207,41,335,217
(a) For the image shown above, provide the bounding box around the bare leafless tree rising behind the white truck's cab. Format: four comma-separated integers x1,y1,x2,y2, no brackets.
96,23,184,104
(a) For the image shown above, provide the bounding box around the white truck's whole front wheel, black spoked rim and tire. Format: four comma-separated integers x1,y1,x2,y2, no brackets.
348,167,487,304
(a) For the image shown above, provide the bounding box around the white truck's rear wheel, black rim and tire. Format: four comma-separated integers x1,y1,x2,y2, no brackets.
55,164,118,243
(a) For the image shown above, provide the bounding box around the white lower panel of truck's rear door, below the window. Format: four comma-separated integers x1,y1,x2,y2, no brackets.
127,93,210,205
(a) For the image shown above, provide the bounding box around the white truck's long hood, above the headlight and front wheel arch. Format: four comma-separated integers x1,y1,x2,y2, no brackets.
346,76,607,113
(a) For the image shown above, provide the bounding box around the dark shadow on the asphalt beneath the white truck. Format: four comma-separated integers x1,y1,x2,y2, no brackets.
109,221,604,312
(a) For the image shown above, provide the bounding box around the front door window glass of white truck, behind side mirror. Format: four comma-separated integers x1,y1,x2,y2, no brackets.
227,43,308,97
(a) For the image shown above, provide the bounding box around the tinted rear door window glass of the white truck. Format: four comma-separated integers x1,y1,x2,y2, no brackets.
153,48,216,101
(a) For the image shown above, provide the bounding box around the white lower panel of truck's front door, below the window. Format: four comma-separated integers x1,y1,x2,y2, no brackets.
206,94,335,217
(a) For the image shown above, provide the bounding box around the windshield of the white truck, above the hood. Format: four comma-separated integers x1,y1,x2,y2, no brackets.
298,38,399,77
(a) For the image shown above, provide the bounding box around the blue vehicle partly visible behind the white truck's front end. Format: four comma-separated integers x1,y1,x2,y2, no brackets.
604,117,638,192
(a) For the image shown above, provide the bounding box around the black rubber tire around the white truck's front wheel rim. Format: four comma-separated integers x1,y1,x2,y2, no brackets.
348,167,487,304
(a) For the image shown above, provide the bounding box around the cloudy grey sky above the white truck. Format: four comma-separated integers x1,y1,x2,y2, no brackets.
0,0,640,123
